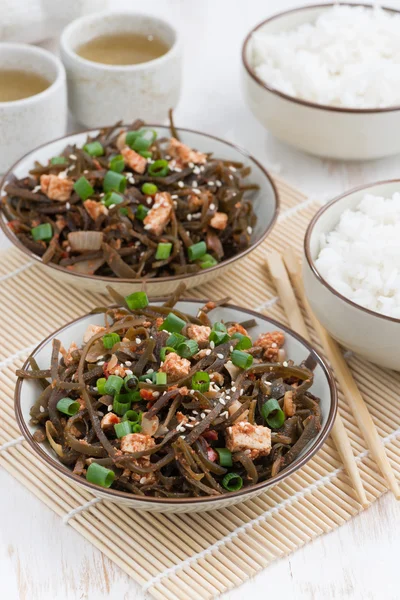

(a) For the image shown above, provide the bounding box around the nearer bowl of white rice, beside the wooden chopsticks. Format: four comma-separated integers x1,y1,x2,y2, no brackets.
303,180,400,371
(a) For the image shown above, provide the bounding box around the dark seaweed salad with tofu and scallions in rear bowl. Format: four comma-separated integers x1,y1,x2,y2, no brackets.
1,115,258,279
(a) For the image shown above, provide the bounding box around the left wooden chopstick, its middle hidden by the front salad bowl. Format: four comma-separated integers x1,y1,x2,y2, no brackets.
267,250,368,507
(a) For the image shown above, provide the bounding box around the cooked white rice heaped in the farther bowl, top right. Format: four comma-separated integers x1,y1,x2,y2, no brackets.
250,5,400,108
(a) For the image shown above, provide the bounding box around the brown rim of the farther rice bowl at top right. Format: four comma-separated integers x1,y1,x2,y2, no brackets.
242,2,400,114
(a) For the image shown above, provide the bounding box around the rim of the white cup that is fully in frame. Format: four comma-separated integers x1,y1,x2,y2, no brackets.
60,10,180,73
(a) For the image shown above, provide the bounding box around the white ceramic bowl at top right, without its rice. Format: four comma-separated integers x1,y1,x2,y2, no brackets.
242,4,400,160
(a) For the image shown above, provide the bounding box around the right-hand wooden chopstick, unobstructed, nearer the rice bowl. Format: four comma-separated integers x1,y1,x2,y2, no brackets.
283,248,400,500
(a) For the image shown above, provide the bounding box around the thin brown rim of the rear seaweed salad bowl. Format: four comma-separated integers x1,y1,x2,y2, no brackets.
0,123,280,285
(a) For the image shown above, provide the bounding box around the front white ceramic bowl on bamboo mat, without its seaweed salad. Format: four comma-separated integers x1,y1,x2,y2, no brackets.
15,299,337,513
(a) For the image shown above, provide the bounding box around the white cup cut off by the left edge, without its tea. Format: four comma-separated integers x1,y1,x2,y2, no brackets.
0,43,67,173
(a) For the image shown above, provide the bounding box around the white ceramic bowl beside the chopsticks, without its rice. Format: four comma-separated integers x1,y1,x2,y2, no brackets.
303,180,400,371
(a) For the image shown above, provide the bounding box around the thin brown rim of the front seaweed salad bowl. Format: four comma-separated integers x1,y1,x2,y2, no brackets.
14,297,338,506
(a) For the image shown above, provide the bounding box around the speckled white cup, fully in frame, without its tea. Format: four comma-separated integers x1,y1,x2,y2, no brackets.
61,11,181,127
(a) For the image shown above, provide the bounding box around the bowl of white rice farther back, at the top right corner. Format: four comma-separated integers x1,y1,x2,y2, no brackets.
242,4,400,160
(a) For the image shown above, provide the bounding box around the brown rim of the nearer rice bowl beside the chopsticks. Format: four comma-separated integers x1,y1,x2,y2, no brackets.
303,179,400,323
